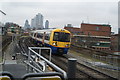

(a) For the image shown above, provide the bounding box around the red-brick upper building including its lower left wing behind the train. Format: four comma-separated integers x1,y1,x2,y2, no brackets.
64,23,111,36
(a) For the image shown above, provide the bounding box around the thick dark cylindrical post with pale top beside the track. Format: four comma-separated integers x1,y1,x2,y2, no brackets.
67,58,77,79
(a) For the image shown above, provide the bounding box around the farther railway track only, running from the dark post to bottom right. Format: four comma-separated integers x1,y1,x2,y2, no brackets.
64,55,117,80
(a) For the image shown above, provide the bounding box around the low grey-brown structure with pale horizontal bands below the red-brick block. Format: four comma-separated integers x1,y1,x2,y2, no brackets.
71,35,111,51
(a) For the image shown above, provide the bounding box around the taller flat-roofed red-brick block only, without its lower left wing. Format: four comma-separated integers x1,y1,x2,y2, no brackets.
81,23,111,36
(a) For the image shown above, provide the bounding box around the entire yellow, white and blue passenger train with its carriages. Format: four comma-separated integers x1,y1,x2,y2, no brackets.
30,29,71,55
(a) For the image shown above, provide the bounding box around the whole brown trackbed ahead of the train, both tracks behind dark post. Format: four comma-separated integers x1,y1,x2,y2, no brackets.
41,52,117,80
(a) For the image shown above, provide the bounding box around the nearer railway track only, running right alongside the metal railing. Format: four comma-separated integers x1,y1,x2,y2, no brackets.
43,55,96,80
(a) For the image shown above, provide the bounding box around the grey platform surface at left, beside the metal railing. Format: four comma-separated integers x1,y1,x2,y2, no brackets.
2,41,27,79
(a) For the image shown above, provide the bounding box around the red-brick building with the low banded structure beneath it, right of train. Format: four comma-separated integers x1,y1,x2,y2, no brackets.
64,23,111,51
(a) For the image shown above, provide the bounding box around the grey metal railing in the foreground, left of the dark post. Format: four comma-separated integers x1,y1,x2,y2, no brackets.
24,47,67,79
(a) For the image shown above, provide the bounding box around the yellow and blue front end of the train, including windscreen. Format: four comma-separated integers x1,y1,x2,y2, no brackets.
50,29,70,54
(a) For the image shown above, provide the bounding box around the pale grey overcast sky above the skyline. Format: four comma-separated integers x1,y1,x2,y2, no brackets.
0,1,118,33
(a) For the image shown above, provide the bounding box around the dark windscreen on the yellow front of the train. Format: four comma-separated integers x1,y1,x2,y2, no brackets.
53,32,70,42
